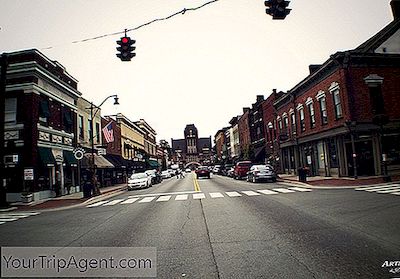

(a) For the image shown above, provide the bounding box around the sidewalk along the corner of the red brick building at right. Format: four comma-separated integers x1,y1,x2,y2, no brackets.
278,174,400,188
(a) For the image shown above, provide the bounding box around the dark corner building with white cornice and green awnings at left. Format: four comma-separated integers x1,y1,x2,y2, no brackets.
2,49,81,201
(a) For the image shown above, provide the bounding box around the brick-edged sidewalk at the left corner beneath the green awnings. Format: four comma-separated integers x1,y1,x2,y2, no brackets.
4,184,127,211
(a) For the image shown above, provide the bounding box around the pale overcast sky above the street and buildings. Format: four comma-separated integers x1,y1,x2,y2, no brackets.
0,0,393,144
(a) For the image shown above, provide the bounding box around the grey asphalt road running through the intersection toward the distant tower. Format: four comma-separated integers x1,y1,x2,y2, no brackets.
0,174,400,278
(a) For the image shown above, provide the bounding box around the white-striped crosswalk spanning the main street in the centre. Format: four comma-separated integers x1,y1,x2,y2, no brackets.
86,187,312,208
